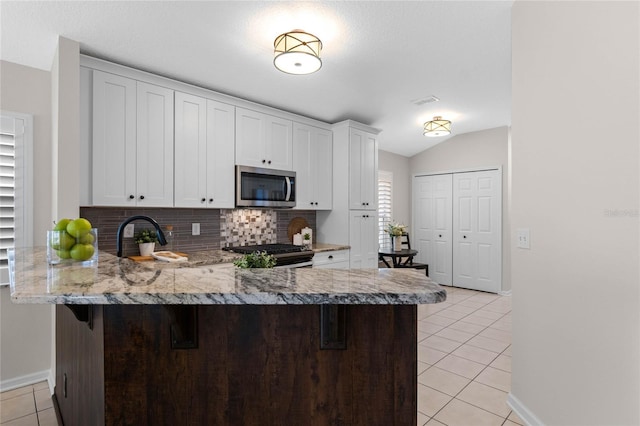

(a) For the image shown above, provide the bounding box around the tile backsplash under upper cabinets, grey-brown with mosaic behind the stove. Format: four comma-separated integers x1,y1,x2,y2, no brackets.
80,207,316,256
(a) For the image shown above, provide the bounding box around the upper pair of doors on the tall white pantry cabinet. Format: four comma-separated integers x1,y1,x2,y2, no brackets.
349,128,378,210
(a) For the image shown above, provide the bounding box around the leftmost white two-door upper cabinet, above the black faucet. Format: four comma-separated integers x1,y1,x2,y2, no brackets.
92,71,173,207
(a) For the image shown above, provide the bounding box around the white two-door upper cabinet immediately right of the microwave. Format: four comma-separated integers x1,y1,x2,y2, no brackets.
293,123,333,210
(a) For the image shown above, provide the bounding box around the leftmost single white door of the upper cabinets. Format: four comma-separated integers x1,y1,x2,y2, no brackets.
92,71,136,206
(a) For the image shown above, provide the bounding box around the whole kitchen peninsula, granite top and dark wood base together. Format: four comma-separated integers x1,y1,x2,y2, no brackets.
10,248,446,425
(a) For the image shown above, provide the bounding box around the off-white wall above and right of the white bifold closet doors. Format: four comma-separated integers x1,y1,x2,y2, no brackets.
409,123,511,291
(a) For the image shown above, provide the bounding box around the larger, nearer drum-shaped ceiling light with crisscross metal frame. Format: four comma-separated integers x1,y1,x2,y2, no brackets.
273,30,322,74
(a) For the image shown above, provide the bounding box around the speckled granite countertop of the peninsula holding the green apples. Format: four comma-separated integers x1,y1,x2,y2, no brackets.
9,248,446,305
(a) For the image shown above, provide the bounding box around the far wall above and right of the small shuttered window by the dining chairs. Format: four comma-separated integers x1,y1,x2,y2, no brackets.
378,150,411,231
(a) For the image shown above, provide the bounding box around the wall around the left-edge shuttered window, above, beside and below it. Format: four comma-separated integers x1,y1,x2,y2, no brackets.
0,61,52,390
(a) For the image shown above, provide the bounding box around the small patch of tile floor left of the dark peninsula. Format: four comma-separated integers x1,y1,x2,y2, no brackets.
0,382,58,426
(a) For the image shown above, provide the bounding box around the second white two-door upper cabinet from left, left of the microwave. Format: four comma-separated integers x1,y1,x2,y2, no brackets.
175,92,235,208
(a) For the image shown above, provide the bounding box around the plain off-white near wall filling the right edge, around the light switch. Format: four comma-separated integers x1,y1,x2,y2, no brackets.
511,1,640,425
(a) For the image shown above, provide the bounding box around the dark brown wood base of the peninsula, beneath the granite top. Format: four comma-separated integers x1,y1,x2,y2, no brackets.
54,304,417,426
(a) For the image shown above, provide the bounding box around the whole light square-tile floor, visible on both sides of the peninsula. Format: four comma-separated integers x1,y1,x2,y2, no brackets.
0,287,524,426
